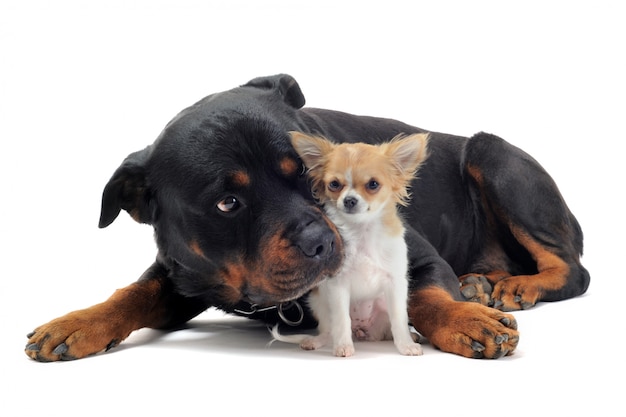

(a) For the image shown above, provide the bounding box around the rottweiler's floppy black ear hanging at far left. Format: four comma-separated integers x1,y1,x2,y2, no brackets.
99,147,154,228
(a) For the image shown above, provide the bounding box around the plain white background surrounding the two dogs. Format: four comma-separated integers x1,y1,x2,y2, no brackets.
0,0,626,416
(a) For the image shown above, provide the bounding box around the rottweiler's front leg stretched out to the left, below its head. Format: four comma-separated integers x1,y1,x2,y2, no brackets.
25,263,206,362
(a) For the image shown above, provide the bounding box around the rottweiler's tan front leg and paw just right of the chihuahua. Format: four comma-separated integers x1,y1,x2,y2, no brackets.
409,285,519,359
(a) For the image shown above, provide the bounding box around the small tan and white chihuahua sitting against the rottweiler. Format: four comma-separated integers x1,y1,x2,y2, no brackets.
272,132,428,357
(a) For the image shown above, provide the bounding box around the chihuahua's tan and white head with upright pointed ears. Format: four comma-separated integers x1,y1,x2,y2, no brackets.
291,132,428,220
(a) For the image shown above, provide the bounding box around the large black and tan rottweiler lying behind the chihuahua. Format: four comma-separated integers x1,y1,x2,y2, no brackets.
26,75,589,361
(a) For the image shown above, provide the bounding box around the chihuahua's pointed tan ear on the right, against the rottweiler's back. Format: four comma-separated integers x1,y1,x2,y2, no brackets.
386,133,428,177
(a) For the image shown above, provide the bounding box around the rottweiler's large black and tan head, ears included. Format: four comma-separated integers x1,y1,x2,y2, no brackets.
100,75,343,306
